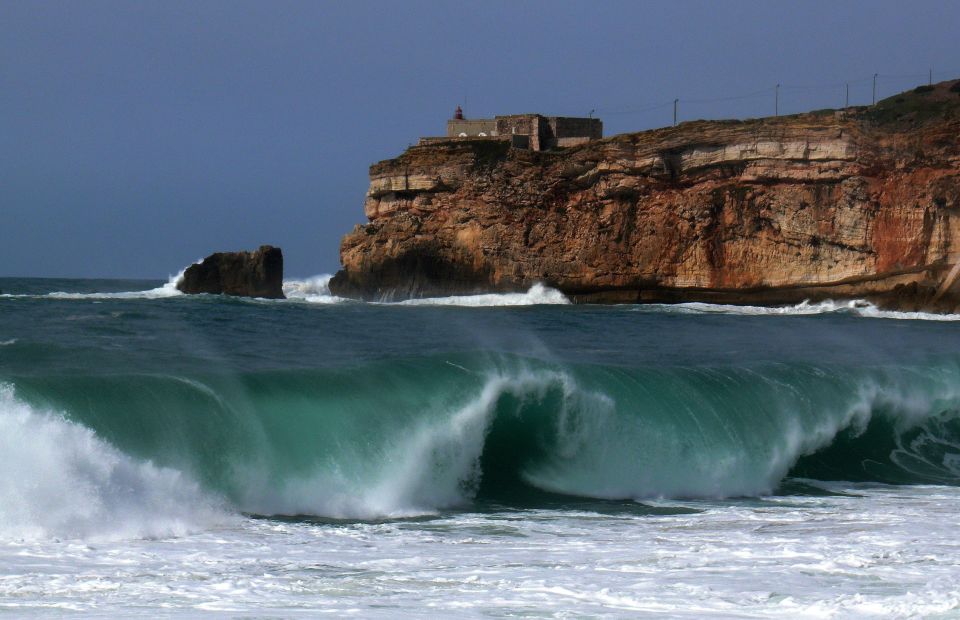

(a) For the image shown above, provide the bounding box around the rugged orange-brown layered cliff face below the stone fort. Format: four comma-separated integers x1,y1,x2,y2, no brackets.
331,82,960,310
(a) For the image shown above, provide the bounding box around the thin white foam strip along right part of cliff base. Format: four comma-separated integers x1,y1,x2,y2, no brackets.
638,299,960,321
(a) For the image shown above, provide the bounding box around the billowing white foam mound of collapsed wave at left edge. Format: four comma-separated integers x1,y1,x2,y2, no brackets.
0,384,228,541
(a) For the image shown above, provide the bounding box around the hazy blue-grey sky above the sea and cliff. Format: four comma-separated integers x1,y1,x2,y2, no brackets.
0,0,960,278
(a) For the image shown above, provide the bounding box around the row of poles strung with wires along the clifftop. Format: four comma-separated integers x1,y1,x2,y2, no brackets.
590,69,960,131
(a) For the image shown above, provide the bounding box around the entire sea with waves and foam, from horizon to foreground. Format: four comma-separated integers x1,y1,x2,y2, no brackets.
0,277,960,618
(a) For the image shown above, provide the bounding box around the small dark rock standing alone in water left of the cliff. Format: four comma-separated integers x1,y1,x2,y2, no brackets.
177,245,283,299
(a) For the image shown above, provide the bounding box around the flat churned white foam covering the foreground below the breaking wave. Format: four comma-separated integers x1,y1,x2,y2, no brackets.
0,484,960,619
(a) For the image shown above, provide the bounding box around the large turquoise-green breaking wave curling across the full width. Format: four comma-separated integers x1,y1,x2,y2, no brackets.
0,356,960,535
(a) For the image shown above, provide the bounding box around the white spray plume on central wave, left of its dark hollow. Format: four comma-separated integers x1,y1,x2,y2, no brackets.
233,361,592,518
